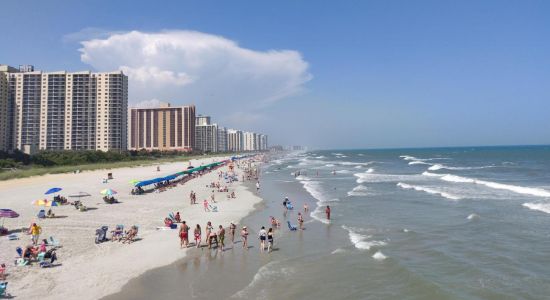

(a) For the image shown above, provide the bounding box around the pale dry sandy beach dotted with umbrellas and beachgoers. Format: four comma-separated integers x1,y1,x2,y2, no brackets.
0,157,261,299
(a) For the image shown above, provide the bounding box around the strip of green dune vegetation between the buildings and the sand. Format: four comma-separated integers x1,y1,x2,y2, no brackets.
0,151,230,180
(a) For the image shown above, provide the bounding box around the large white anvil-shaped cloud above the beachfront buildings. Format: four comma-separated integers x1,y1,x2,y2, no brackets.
80,31,312,126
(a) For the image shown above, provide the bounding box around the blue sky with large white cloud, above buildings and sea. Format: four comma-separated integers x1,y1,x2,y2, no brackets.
0,0,550,149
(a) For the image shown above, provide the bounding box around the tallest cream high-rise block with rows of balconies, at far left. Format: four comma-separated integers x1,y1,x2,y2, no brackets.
2,66,128,153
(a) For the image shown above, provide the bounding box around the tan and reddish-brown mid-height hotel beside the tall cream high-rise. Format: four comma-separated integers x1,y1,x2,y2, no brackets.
128,103,195,152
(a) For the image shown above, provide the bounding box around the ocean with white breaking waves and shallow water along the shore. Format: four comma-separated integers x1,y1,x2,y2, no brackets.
106,146,550,299
